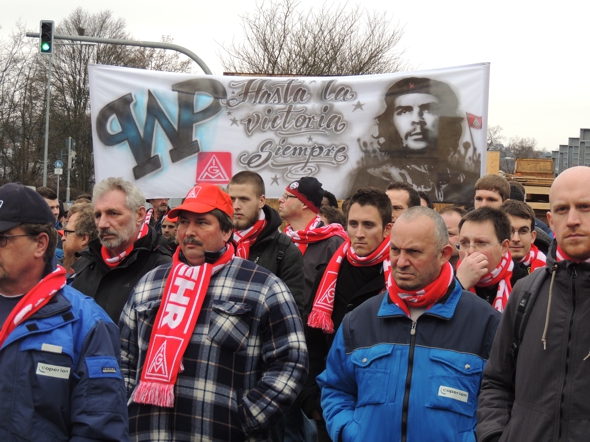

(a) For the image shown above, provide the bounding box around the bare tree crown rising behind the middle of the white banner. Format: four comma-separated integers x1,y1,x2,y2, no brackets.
219,0,407,75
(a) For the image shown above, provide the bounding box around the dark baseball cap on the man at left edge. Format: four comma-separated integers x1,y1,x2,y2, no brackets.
0,183,55,232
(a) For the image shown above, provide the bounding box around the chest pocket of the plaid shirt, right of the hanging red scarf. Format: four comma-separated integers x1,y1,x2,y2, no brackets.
208,301,252,352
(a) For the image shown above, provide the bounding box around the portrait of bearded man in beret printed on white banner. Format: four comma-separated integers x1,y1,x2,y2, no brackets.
349,77,480,203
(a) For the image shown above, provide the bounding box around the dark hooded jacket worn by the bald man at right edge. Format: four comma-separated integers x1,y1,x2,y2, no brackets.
477,243,590,442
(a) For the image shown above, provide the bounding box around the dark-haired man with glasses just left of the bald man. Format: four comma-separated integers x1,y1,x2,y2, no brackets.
500,200,547,287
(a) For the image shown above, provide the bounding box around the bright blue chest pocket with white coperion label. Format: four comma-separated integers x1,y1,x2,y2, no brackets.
427,349,484,418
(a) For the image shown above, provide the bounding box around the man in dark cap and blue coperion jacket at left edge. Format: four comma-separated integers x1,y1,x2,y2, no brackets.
0,183,128,441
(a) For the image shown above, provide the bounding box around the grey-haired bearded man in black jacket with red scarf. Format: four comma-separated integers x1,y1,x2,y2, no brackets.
72,177,172,322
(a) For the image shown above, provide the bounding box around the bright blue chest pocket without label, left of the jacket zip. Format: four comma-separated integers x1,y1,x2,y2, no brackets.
351,345,395,407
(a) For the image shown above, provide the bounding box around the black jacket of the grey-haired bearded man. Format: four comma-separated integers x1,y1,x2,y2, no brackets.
68,227,172,324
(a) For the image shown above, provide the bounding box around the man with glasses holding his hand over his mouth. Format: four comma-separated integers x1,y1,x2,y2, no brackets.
457,207,514,312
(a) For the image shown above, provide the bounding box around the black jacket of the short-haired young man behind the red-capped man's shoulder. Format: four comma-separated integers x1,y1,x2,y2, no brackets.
248,205,304,314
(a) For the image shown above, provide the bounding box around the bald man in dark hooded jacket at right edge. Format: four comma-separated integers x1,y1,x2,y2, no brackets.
477,166,590,442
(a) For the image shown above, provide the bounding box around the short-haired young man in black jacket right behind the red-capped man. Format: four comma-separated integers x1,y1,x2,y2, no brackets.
228,171,303,312
